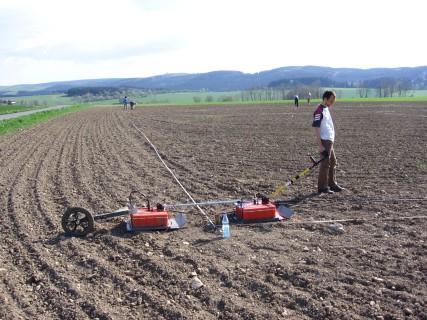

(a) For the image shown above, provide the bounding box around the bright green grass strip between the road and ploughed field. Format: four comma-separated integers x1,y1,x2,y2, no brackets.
0,105,89,135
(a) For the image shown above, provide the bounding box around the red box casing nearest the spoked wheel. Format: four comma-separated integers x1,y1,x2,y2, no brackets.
130,208,169,229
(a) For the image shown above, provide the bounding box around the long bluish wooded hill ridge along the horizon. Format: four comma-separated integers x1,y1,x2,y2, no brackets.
0,66,427,96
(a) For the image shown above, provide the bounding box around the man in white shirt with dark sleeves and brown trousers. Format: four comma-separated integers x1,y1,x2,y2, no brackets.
312,90,344,193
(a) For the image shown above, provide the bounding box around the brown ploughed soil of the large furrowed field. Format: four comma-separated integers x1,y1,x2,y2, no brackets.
0,103,427,319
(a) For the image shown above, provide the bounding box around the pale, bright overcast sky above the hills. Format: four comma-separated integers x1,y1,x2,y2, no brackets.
0,0,427,85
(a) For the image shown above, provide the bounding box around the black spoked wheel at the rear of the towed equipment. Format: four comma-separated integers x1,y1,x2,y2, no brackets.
62,207,95,236
